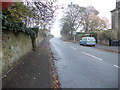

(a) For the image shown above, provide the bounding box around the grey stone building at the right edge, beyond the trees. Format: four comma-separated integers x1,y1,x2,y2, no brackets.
111,0,120,40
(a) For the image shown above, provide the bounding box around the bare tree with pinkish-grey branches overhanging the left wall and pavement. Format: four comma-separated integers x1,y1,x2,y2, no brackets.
25,0,58,27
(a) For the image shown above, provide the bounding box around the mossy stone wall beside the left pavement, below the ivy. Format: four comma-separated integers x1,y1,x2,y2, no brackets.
2,31,43,75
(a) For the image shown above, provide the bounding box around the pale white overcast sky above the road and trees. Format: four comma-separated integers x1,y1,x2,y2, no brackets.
51,0,116,36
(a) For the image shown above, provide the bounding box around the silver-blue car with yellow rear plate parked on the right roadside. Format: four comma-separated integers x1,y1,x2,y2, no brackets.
80,37,96,46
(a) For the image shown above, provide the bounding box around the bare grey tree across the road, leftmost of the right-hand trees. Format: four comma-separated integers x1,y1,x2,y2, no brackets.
61,4,83,34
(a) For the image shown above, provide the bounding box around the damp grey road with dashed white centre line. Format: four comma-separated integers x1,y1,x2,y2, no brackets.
50,38,120,88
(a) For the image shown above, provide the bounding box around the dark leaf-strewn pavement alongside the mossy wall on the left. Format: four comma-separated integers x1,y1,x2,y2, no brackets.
2,38,54,90
